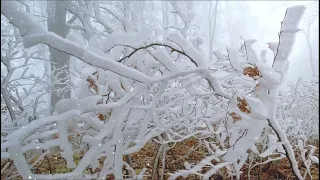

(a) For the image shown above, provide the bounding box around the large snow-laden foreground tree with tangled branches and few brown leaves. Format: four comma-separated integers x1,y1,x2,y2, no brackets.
1,1,315,179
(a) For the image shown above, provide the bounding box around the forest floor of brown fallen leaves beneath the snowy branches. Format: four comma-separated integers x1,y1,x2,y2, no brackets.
1,139,319,180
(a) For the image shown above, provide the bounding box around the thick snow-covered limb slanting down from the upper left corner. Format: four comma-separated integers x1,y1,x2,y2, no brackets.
1,1,151,82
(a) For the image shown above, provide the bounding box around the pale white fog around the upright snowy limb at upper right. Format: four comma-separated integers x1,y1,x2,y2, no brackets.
194,1,319,87
